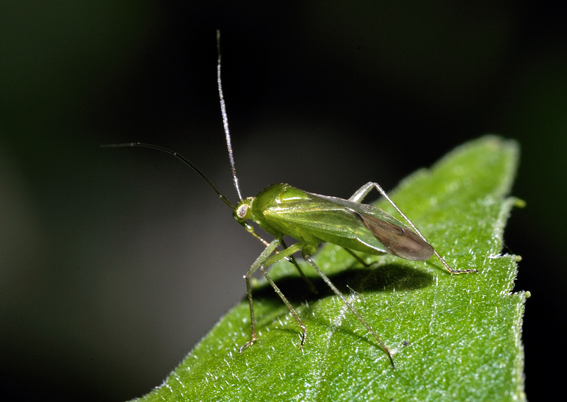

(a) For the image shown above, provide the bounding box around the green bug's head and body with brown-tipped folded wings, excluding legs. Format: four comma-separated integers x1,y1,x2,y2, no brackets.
235,183,433,260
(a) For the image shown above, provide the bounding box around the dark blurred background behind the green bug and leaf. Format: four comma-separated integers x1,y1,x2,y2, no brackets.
0,0,567,401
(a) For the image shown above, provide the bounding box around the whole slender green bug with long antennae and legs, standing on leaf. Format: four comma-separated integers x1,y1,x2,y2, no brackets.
102,31,477,369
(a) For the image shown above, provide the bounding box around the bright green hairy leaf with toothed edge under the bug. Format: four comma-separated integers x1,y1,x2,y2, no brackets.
131,136,526,401
